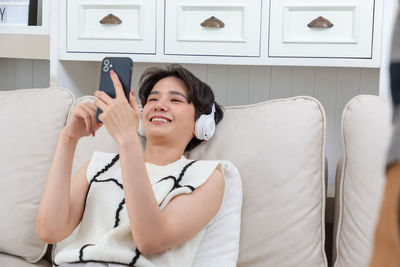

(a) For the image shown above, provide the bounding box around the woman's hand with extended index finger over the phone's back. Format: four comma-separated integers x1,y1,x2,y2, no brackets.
94,71,140,145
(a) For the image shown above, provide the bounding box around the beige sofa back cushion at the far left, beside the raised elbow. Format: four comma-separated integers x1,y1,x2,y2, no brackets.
0,88,74,266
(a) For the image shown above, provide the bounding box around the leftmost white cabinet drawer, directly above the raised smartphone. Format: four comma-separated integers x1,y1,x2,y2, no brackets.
67,0,156,54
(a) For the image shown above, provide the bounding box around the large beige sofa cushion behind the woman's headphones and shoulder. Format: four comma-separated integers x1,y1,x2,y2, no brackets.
189,97,327,267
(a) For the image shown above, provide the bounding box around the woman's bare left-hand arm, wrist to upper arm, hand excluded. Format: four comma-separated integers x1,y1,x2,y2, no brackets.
36,130,89,244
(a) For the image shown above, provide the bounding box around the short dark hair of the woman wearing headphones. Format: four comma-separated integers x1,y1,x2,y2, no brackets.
139,64,224,151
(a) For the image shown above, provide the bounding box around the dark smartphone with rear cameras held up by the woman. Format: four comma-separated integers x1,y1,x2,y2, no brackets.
96,57,133,123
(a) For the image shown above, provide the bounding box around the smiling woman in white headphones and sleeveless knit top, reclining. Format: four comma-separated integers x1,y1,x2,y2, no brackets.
37,65,225,267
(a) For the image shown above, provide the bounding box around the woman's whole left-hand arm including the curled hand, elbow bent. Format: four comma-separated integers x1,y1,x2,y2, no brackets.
36,99,101,243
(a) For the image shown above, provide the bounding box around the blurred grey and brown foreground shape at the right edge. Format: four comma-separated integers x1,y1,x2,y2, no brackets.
370,5,400,267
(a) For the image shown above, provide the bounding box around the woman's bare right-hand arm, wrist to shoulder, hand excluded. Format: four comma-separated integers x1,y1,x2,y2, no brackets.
120,137,225,254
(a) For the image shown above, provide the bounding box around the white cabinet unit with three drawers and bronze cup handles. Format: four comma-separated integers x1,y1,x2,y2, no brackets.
56,0,384,67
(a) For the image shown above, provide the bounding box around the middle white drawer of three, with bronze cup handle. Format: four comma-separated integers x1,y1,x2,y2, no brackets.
165,0,261,56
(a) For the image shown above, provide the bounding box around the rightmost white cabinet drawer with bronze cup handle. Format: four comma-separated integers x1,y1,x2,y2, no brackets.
269,0,374,58
